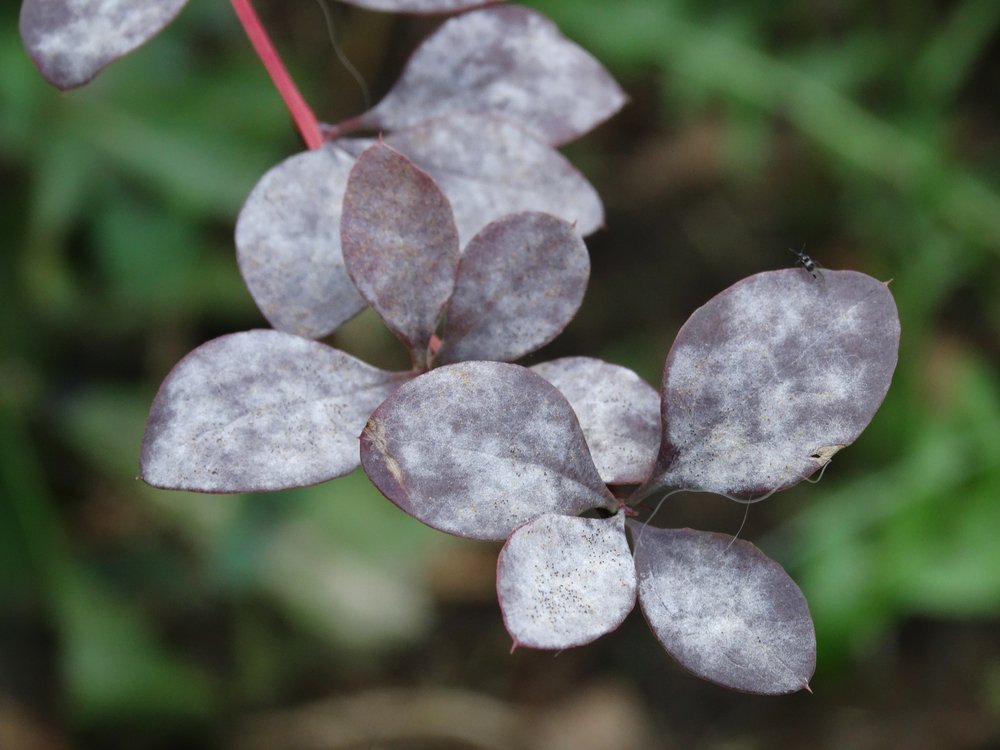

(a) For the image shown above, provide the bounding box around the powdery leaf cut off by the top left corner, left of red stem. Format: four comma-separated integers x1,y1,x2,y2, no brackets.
20,0,187,89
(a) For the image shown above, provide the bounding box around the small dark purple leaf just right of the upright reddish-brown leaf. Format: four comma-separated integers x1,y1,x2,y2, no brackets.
438,212,590,363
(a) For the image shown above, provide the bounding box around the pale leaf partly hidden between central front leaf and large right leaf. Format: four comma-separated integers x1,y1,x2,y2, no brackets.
531,357,660,484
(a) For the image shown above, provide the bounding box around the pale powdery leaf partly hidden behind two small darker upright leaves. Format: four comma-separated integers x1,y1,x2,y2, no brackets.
378,115,604,246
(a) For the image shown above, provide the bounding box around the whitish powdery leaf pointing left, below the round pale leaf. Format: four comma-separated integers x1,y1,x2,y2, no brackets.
140,330,406,492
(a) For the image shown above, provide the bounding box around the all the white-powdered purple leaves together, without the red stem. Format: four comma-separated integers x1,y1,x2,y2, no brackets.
21,0,899,693
